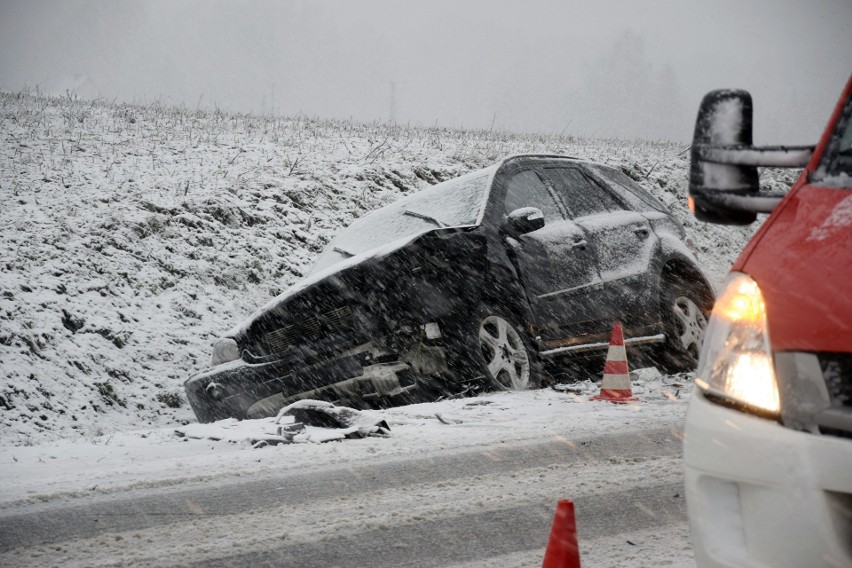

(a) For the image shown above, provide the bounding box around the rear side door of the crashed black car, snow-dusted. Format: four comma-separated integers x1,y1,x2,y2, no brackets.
544,165,659,335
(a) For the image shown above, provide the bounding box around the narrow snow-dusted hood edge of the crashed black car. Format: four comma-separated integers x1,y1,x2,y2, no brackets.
225,225,473,337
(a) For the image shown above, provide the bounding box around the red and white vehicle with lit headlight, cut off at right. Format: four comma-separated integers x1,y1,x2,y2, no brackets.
684,77,852,568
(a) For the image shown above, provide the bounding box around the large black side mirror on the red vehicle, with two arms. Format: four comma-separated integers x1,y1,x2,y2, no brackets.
689,89,813,225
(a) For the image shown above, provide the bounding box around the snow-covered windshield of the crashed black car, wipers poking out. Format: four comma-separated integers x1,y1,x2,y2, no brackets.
311,166,496,273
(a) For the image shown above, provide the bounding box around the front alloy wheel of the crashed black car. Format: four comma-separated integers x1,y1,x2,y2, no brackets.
479,315,532,390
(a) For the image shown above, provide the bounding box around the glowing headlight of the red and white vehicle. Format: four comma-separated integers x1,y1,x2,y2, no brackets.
695,273,781,417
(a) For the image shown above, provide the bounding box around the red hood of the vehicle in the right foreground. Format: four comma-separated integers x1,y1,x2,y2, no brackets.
734,185,852,353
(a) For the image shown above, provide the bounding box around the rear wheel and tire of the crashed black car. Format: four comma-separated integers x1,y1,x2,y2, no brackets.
655,278,713,374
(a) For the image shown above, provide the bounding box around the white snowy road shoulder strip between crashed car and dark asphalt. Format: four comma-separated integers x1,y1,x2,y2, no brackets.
0,372,692,509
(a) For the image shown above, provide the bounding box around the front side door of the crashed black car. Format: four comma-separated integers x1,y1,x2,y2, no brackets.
503,168,600,340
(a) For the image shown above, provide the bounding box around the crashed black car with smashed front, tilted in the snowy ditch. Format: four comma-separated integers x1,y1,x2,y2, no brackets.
185,155,714,422
